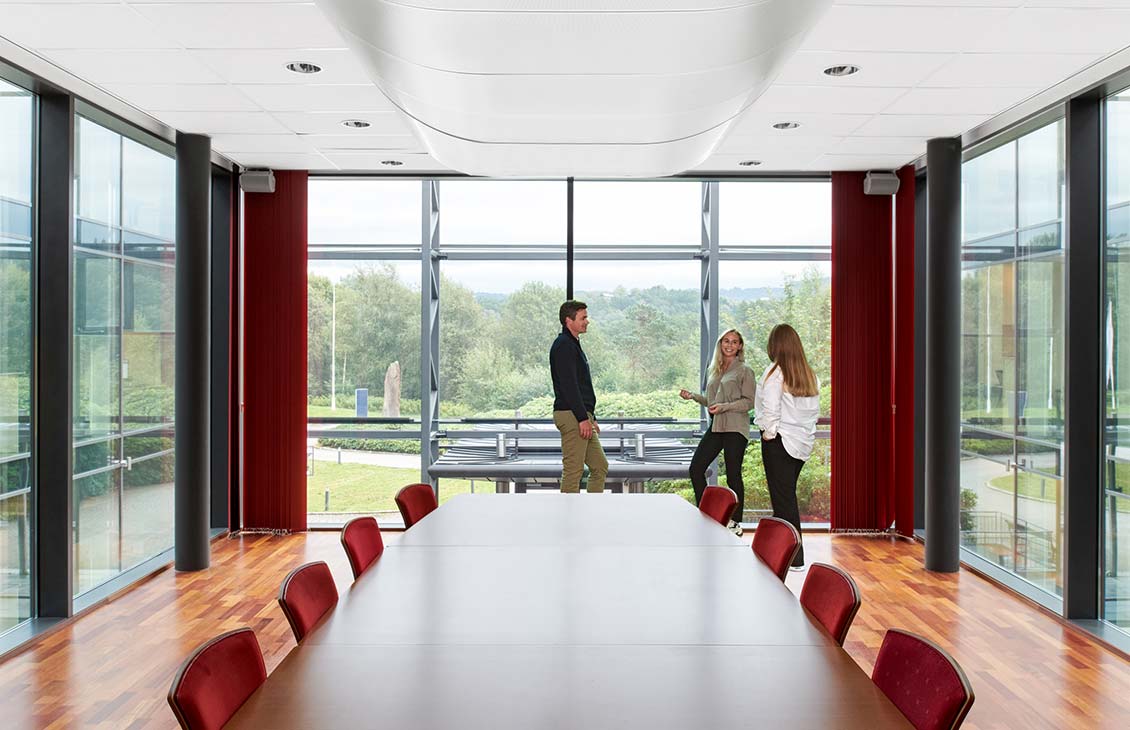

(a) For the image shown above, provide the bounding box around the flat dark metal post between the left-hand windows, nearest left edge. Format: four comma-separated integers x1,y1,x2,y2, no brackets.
35,94,75,618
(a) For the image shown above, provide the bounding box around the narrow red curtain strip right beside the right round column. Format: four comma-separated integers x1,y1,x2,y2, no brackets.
892,165,915,536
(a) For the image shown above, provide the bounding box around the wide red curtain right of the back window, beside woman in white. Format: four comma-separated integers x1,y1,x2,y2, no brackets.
832,172,895,530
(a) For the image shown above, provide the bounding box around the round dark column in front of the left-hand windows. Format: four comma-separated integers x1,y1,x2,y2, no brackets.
174,132,211,571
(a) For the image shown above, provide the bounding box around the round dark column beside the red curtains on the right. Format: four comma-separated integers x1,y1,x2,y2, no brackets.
925,138,962,573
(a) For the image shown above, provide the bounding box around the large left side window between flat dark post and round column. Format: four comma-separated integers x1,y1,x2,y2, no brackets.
73,115,176,594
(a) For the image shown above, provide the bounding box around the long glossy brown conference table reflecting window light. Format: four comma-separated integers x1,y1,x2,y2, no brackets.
227,494,911,730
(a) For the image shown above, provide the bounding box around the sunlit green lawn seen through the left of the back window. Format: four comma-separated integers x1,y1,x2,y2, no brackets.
306,461,481,512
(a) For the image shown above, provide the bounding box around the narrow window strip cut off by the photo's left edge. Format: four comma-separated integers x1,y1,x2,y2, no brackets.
0,75,35,633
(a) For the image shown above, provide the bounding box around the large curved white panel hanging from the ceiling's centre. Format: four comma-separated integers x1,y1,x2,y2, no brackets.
318,0,831,177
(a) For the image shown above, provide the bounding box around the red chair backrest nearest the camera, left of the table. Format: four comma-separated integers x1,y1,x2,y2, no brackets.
168,628,267,730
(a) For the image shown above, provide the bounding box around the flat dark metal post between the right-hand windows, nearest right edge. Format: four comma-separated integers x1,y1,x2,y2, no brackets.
1063,96,1105,618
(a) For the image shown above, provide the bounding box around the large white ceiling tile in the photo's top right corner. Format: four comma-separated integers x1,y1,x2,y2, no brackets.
966,8,1130,55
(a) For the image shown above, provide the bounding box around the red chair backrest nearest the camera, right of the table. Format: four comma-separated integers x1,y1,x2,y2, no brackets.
871,628,974,730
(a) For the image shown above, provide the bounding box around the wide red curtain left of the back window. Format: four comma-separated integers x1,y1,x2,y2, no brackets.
242,172,307,531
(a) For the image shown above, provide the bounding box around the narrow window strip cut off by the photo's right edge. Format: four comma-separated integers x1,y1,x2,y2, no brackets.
1102,92,1130,629
